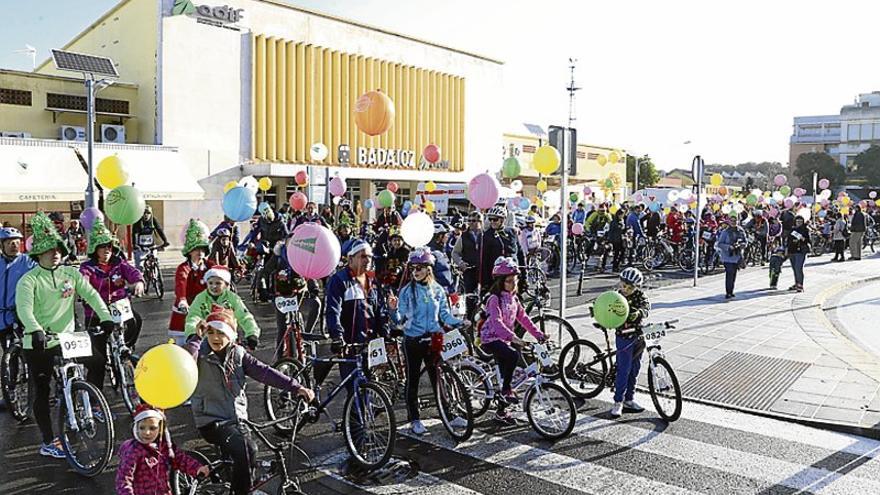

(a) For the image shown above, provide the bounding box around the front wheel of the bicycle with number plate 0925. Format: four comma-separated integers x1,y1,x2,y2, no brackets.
58,380,115,478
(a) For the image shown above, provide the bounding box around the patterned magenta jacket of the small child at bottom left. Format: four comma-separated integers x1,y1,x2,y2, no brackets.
116,438,202,495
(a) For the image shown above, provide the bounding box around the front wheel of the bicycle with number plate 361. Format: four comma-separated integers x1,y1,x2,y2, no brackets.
342,382,397,470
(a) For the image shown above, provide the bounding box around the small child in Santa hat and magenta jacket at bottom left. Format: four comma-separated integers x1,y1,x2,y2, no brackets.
116,404,210,495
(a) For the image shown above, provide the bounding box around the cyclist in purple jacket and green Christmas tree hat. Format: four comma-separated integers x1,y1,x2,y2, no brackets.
79,222,144,390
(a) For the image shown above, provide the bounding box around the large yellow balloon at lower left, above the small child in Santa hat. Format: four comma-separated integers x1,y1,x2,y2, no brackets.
134,342,199,409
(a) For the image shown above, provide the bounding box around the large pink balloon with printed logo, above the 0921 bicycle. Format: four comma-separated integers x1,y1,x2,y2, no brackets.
287,223,341,280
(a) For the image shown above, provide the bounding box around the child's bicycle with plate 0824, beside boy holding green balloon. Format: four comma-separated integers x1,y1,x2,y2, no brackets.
559,320,681,421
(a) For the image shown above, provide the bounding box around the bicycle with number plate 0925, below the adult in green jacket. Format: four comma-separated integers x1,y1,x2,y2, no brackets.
47,332,116,478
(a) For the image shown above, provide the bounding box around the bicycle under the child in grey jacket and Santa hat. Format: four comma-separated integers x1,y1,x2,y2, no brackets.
171,412,311,495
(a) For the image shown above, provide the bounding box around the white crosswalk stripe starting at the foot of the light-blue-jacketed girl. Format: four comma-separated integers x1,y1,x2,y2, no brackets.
398,420,697,495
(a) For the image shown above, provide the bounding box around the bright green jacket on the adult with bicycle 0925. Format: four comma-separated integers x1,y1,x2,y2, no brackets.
15,265,112,349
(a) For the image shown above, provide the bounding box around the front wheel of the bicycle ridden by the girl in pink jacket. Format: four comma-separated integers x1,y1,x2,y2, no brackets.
525,382,577,440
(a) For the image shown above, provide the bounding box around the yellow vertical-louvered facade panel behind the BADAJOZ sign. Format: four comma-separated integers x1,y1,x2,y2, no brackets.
251,35,465,172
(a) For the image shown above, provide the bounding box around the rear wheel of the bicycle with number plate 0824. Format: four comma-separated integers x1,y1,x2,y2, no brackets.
559,339,608,399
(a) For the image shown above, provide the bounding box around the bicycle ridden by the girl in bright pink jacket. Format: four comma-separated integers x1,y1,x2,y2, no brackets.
456,343,577,440
